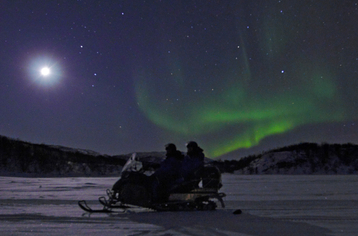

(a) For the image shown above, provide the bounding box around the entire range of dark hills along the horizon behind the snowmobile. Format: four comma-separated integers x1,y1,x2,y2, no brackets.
0,136,358,177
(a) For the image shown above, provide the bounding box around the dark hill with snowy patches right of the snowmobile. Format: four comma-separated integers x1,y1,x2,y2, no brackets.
215,143,358,174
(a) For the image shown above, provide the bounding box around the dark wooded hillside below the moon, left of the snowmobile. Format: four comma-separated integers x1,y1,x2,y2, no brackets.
0,136,128,175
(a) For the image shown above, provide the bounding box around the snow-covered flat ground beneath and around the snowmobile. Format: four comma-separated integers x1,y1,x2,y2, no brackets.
0,174,358,236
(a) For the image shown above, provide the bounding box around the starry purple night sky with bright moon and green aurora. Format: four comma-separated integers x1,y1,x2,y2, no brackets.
0,0,358,158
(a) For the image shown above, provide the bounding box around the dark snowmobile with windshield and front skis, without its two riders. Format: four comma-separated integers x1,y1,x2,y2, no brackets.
78,153,226,213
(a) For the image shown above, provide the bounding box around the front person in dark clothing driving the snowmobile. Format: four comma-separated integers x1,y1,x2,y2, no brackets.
151,143,184,201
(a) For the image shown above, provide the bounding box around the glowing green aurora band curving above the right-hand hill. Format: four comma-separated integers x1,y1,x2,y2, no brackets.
136,62,344,157
